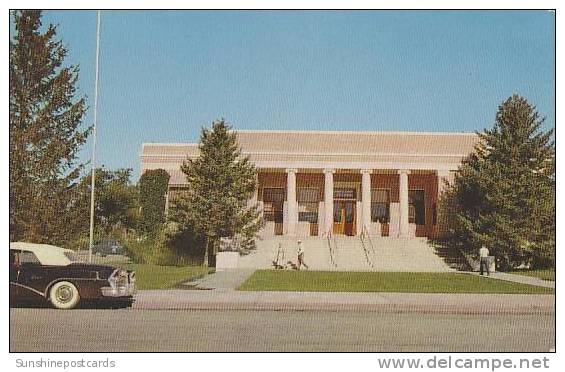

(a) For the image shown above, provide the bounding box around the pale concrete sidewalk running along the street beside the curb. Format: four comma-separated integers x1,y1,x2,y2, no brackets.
134,289,555,314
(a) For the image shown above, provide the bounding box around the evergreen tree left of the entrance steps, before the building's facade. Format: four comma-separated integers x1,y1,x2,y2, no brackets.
170,120,262,265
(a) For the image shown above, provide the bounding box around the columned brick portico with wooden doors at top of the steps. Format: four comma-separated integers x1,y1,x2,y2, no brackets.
257,168,452,238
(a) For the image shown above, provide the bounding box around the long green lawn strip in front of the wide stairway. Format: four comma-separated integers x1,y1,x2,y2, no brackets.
239,270,553,293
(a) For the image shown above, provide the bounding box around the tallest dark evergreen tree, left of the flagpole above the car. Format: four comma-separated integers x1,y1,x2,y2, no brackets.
9,10,89,244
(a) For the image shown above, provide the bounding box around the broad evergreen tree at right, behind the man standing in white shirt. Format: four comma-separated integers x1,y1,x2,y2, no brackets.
447,95,555,270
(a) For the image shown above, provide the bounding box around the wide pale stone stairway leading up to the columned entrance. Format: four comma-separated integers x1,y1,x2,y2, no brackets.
238,236,453,272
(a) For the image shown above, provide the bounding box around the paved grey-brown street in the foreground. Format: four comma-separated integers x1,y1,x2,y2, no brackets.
10,308,555,352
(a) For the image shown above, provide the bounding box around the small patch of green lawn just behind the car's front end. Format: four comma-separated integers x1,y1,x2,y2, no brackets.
122,264,214,289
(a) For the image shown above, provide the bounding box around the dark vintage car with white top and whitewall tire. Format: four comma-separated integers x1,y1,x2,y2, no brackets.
10,242,136,309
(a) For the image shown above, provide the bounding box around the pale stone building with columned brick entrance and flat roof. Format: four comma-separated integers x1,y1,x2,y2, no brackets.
140,130,478,237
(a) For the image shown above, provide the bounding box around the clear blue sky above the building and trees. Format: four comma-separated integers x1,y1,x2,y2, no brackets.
36,11,555,181
